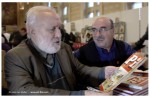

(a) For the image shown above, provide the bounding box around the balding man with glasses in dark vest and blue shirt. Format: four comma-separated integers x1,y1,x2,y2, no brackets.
74,17,147,72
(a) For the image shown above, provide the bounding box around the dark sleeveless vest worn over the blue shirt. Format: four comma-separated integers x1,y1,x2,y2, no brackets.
78,40,129,67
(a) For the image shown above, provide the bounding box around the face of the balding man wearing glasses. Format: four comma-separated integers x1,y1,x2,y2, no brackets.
92,18,114,50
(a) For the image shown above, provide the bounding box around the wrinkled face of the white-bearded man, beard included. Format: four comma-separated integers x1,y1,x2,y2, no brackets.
31,12,61,54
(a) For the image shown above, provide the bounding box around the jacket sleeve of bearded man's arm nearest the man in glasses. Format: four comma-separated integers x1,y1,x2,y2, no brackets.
66,45,105,87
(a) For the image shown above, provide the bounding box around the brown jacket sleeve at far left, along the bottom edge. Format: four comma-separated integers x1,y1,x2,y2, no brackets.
5,51,84,95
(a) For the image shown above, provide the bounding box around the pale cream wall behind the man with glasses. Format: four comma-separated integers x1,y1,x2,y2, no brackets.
65,7,148,42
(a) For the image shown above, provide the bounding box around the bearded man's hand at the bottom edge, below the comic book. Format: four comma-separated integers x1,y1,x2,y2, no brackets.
85,90,112,96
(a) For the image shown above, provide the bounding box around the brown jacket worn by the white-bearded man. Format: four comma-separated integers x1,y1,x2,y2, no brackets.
5,41,104,95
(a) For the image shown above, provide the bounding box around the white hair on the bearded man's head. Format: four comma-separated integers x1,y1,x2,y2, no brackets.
26,6,56,37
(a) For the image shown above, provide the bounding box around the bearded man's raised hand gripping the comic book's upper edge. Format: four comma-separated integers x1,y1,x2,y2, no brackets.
105,66,118,78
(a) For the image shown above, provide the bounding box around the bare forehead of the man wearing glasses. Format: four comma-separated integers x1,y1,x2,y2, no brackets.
92,18,110,27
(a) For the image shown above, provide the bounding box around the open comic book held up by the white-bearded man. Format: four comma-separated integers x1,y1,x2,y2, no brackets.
99,52,147,92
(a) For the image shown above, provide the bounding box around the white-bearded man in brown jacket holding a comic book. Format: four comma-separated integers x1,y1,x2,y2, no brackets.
5,6,117,95
